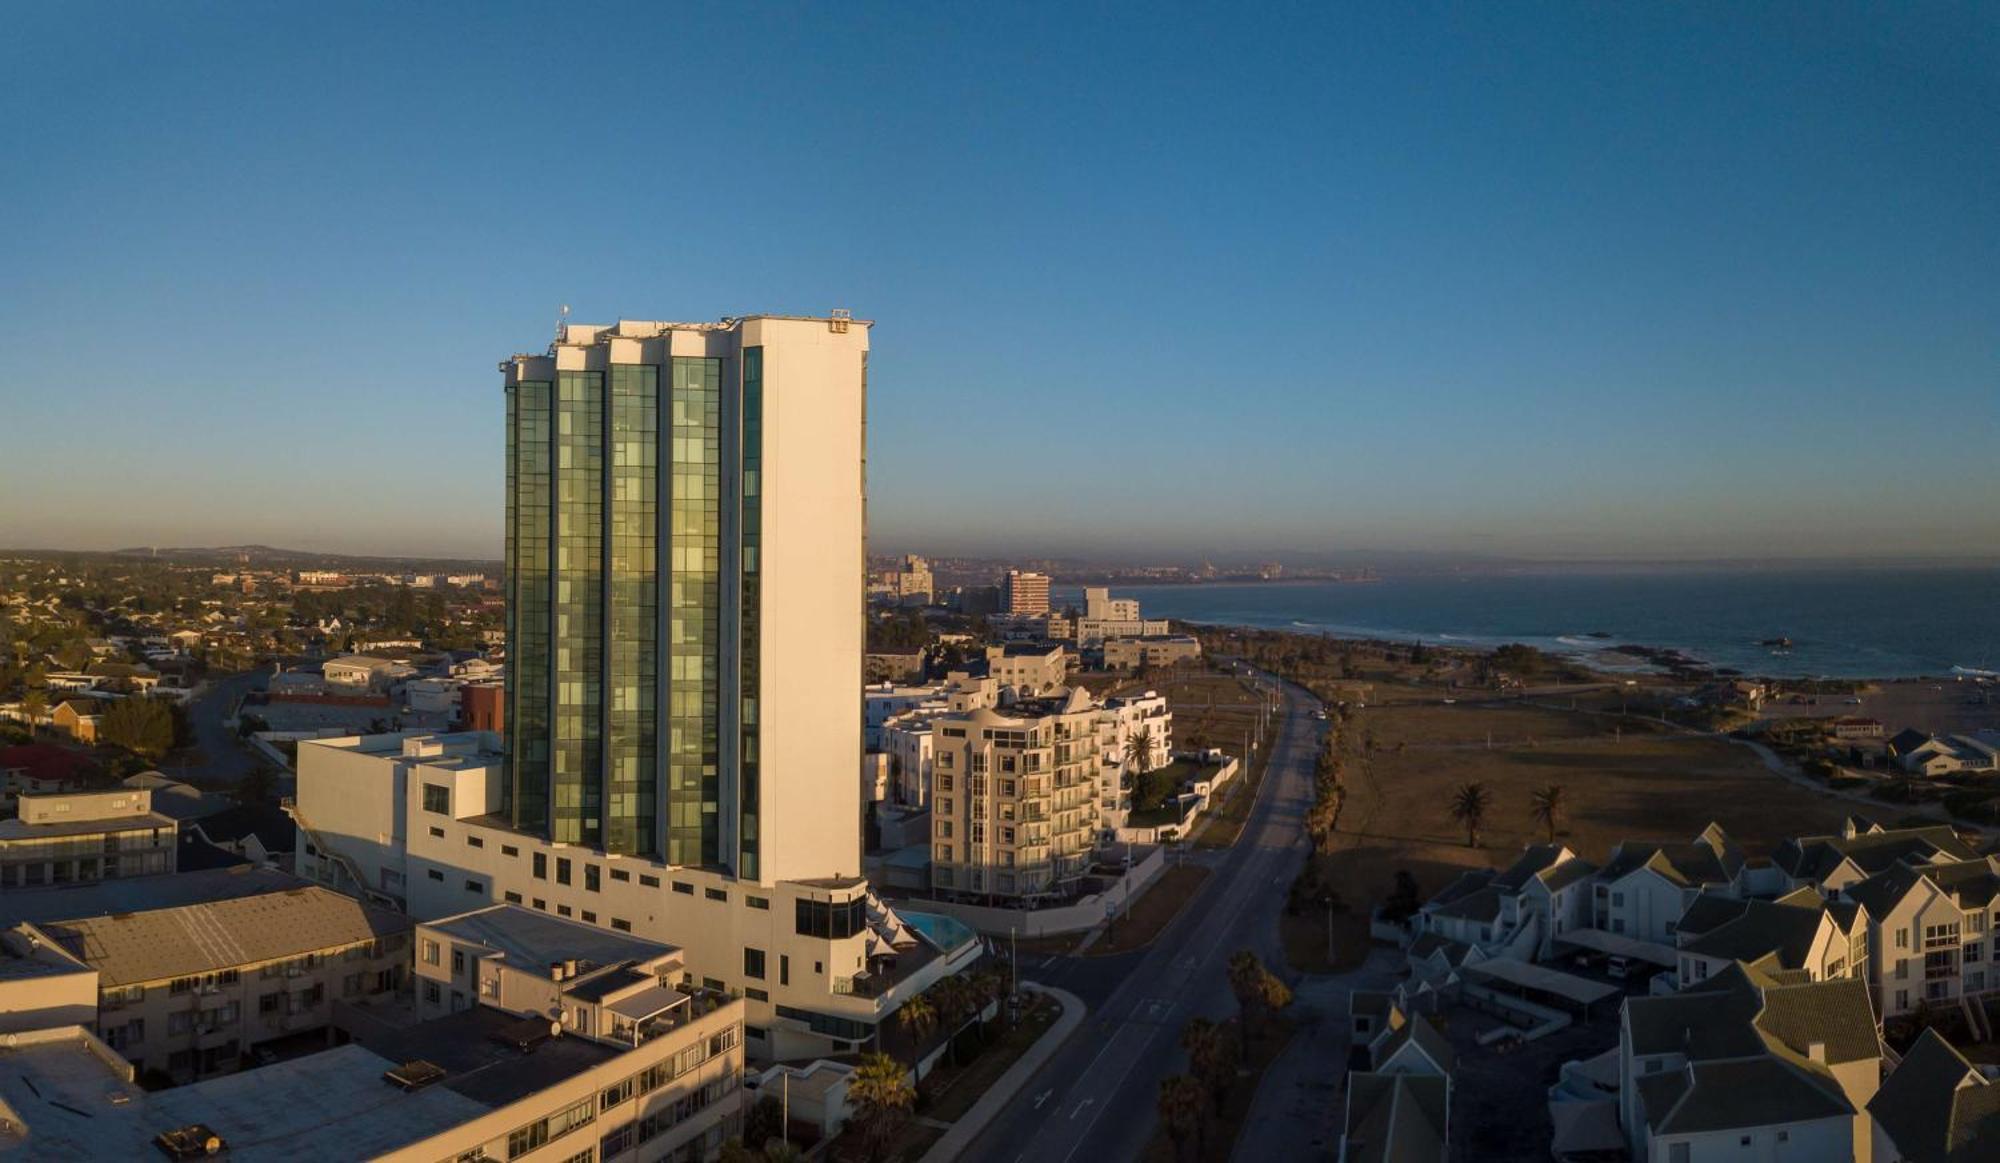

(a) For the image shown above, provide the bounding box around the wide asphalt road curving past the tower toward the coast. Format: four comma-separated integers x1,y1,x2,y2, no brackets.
964,675,1320,1163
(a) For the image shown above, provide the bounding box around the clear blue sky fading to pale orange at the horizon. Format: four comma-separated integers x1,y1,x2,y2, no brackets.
0,4,2000,558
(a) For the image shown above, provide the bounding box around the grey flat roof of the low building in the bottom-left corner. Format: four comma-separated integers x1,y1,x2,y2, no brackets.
0,1009,620,1161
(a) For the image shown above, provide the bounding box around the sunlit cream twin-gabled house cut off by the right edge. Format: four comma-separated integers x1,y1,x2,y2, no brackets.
1842,857,2000,1017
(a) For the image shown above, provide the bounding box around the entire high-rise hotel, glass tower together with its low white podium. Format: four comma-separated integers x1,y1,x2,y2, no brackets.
296,316,978,1057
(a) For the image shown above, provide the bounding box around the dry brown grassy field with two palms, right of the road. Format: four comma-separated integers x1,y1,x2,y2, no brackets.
1280,699,1854,971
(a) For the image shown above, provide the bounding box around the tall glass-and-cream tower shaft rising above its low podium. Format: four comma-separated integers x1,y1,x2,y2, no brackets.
502,316,868,881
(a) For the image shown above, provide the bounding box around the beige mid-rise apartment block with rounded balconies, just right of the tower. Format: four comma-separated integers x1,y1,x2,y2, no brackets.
930,687,1100,899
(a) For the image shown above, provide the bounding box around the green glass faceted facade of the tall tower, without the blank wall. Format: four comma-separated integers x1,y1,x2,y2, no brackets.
504,337,764,879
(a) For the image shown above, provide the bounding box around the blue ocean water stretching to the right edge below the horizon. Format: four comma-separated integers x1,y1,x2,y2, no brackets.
1096,570,2000,677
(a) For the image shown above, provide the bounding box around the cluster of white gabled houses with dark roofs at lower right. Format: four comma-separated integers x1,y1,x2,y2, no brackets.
1400,819,2000,1163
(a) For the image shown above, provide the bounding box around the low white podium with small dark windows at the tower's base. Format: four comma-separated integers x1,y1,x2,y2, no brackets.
294,739,982,1059
